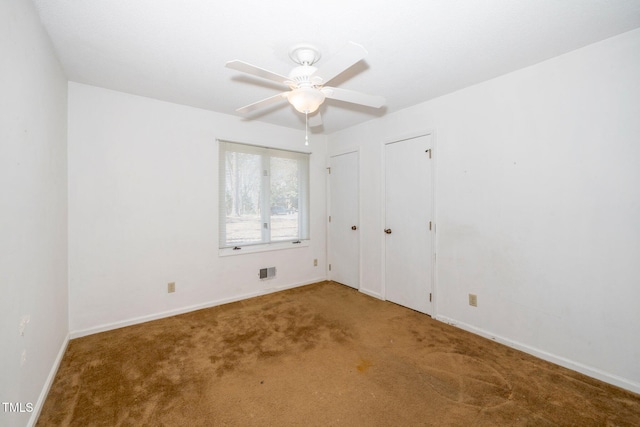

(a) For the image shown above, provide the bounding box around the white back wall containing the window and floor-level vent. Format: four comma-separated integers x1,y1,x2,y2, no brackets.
68,83,326,336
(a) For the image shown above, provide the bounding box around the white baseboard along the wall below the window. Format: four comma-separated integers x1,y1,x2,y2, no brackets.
69,277,326,339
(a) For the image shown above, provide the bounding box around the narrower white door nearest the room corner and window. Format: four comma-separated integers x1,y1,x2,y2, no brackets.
329,152,360,289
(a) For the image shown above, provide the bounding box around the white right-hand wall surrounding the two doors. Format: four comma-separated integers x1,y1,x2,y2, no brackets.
329,30,640,392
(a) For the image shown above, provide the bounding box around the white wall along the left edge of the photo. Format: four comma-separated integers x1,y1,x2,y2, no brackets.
0,1,68,426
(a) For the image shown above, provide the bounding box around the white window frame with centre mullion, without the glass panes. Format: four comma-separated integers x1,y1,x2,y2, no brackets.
217,139,311,256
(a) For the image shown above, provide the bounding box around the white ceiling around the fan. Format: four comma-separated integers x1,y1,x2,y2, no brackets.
33,0,640,133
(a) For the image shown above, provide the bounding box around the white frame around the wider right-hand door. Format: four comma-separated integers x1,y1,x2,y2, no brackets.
379,129,438,319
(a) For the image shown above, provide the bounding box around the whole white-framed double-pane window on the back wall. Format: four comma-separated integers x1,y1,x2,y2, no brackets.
218,140,309,248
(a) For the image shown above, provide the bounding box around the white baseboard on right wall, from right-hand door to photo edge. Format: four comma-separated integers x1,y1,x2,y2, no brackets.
435,316,640,394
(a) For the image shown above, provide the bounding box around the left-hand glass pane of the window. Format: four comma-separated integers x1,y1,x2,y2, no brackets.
225,151,262,245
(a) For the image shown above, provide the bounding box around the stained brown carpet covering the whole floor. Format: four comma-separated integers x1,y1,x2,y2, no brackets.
38,282,640,426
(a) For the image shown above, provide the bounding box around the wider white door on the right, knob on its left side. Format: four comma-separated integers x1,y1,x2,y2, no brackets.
380,135,433,314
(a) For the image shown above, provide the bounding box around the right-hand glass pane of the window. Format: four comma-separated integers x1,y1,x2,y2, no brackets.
270,157,300,241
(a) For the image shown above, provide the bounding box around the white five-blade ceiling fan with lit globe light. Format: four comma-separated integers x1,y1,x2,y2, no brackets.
226,42,386,126
